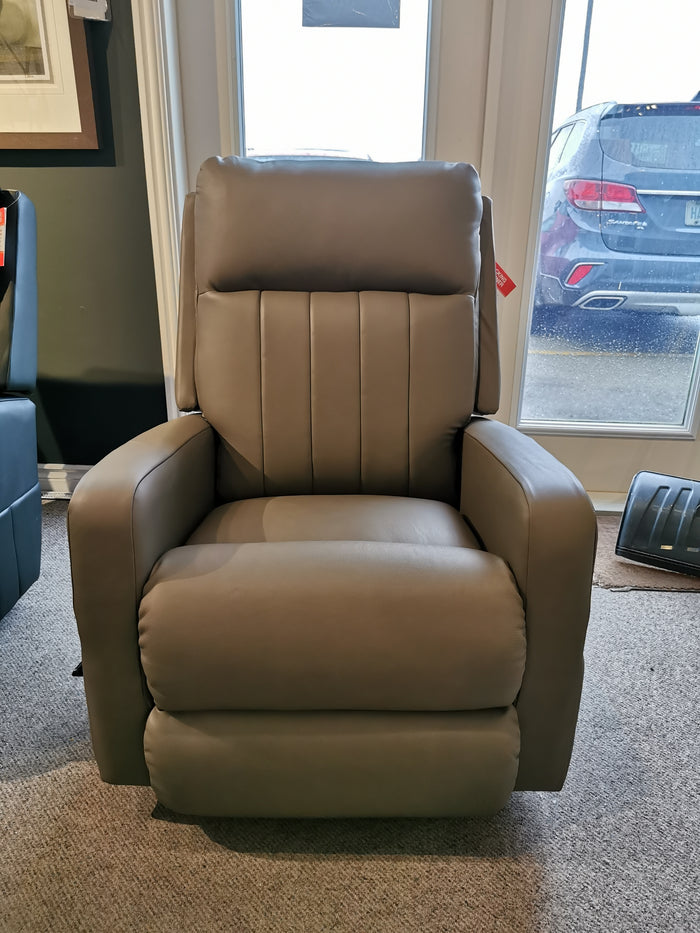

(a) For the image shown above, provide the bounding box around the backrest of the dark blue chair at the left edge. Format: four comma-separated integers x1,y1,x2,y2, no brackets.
0,191,37,393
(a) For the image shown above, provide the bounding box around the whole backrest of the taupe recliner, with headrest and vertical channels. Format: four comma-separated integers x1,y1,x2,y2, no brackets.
176,158,498,502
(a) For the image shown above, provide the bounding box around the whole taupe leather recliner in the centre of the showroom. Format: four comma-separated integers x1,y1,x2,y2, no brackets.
69,158,595,816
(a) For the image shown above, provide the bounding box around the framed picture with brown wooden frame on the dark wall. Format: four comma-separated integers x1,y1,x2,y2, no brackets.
0,0,98,149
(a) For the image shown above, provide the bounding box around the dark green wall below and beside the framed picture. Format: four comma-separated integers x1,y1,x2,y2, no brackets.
0,0,166,464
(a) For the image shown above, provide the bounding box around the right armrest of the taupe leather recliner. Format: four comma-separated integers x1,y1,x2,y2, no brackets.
461,418,596,790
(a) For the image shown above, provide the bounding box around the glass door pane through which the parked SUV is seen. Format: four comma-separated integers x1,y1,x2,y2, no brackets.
519,0,700,436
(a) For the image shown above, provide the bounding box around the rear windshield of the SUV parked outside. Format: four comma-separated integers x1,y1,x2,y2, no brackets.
600,104,700,171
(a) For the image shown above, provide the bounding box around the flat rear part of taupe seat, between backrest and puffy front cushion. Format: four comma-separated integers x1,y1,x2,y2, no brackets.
187,495,479,548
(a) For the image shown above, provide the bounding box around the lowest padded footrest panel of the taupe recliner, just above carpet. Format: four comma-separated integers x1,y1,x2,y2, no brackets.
145,706,520,818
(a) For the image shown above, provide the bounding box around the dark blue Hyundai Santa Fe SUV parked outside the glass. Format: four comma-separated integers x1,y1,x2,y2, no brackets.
535,100,700,320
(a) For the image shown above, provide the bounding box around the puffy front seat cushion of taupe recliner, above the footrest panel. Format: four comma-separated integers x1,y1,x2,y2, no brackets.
139,541,525,712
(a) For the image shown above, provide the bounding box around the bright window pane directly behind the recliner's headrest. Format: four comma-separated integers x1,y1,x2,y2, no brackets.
237,0,430,161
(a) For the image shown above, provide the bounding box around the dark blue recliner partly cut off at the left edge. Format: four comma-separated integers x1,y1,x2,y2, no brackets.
0,191,41,617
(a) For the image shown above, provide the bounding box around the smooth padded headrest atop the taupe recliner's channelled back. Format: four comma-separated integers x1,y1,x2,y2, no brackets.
195,157,482,295
